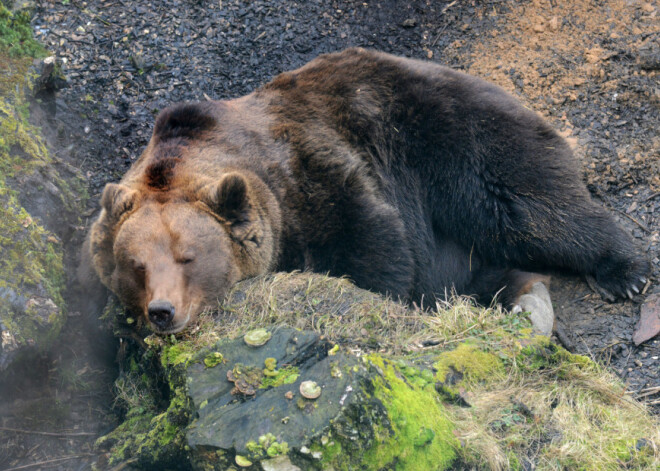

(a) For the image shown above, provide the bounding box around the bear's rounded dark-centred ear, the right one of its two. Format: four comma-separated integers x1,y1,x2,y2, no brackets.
201,173,251,225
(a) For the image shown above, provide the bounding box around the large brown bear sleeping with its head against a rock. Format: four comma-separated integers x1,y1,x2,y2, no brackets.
81,49,650,333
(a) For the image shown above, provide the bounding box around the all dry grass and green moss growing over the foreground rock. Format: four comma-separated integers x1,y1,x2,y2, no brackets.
103,274,660,471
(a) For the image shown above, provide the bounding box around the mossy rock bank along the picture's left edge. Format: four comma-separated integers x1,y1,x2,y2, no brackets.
0,5,84,371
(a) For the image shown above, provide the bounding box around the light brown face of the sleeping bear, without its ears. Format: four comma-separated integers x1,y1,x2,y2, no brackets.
110,203,241,333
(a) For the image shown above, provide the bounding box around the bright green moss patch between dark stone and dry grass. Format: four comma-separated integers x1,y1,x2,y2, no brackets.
363,354,458,470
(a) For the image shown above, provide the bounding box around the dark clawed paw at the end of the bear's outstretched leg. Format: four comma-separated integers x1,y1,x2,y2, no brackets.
587,256,651,301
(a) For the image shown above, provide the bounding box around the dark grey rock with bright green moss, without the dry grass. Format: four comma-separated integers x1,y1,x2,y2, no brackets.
105,328,458,470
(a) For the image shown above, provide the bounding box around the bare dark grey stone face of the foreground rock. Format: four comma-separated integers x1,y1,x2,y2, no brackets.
186,328,386,469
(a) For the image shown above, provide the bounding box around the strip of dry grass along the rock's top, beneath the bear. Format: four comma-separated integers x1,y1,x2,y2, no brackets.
177,273,506,354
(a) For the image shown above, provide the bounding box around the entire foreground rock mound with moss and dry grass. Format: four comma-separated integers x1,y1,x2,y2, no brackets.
99,273,660,470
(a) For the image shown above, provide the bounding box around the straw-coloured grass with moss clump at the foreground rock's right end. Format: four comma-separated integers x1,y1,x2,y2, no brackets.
446,333,660,470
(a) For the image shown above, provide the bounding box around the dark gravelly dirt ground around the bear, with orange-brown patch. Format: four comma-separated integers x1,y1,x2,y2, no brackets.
0,0,660,470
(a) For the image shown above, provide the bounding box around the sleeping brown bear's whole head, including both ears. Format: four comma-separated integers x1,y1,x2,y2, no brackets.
89,172,281,334
